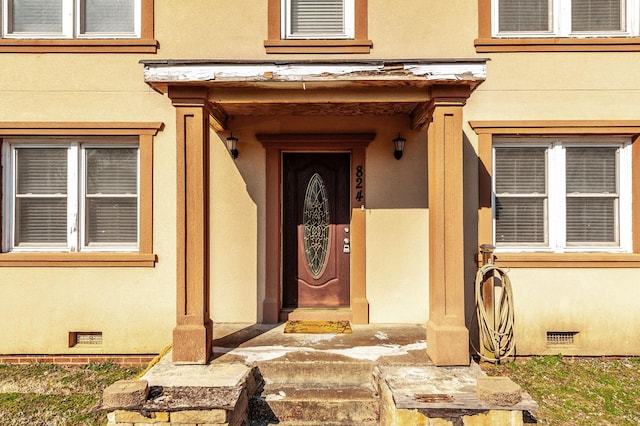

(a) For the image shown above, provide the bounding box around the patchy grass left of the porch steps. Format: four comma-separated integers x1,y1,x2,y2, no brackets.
0,362,142,426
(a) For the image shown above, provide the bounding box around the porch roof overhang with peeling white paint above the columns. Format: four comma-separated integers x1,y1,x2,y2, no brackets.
141,59,487,130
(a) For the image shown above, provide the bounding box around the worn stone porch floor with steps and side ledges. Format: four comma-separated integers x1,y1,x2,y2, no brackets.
103,324,536,426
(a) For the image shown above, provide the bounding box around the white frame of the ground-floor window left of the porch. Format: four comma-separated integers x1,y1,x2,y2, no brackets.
2,138,140,253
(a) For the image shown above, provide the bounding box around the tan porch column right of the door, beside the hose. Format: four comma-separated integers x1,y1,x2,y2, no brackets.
427,86,470,366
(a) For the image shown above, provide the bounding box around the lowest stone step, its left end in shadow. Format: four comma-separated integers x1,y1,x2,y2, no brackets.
250,384,380,425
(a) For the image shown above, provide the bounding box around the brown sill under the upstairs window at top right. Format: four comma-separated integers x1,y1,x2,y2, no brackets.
474,37,640,53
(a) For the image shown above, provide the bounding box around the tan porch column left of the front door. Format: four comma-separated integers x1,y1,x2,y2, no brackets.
169,87,213,364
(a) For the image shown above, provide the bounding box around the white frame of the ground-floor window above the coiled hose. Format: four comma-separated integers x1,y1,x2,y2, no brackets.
491,136,633,253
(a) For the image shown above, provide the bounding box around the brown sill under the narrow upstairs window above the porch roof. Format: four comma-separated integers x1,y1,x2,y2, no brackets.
264,39,373,53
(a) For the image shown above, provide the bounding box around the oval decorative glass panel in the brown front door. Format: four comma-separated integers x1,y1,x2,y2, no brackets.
302,173,330,277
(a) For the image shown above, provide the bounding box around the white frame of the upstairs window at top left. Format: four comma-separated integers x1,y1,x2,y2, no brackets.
0,0,142,39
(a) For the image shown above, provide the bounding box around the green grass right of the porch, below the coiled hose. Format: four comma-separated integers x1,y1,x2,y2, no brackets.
481,355,640,426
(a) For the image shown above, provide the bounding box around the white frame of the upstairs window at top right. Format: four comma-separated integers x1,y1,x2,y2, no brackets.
491,0,640,38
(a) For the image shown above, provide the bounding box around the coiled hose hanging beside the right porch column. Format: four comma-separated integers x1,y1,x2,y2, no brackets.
474,263,515,364
